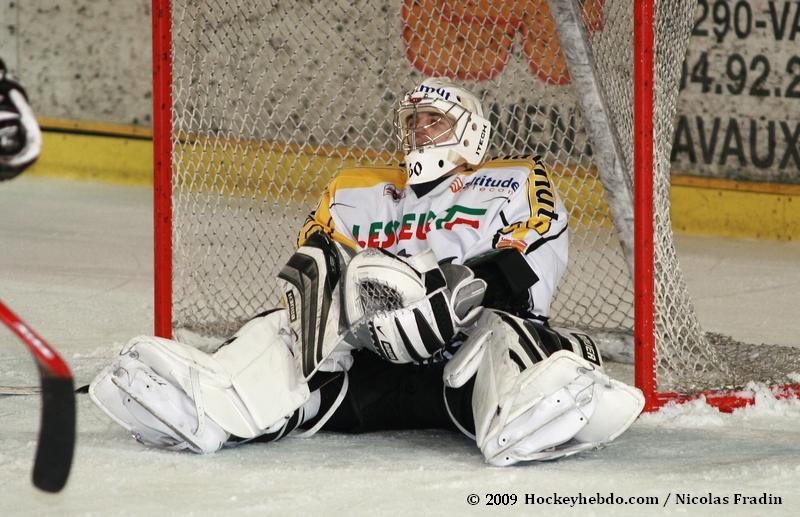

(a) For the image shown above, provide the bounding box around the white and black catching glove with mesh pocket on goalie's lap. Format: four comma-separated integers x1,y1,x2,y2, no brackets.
344,248,486,364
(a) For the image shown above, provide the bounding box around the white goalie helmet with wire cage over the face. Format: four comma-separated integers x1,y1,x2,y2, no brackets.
394,78,492,185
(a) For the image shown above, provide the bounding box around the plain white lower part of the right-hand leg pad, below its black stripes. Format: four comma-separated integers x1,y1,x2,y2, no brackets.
473,343,644,466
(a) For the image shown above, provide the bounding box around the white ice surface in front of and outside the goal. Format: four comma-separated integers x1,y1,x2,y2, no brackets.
0,177,800,516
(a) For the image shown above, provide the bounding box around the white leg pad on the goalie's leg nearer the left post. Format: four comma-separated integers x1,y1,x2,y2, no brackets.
90,310,310,452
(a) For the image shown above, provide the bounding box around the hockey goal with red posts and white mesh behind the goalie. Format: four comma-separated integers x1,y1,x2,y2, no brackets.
153,0,800,409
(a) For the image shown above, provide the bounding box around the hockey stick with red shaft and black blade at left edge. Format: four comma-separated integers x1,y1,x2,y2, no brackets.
0,301,75,492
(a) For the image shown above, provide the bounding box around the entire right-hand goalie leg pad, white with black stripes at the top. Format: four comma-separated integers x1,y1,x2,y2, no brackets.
444,311,644,466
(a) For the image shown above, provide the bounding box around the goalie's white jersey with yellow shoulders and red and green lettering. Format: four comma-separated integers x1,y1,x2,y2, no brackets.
299,158,568,317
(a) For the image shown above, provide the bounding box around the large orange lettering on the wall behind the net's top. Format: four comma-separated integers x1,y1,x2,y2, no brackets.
402,0,604,84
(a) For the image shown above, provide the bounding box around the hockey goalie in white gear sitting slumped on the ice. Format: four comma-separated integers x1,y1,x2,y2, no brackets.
90,79,644,466
